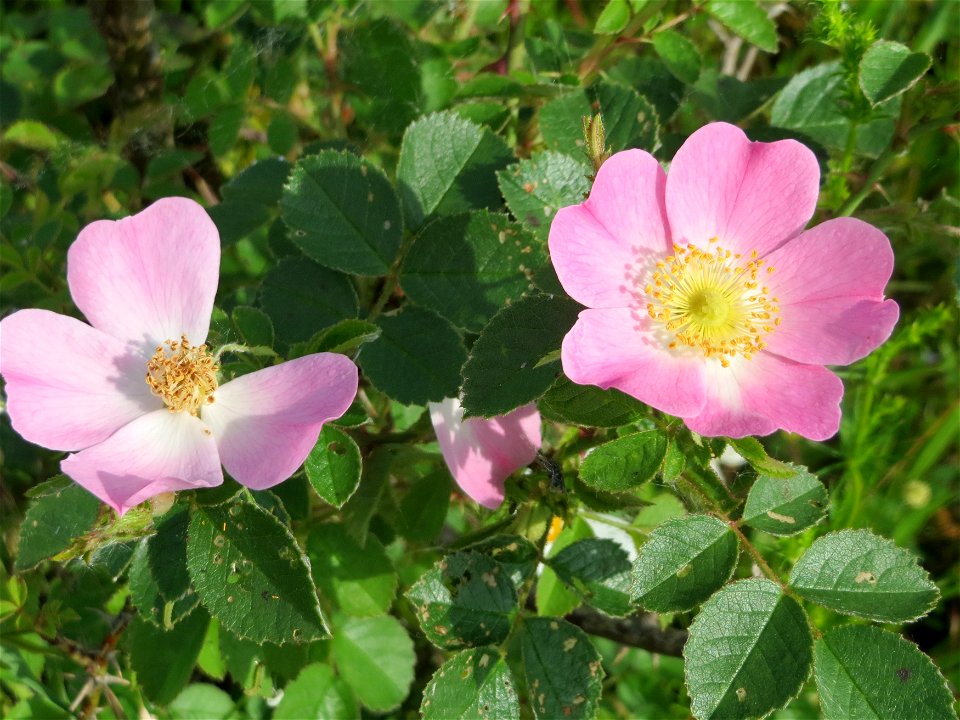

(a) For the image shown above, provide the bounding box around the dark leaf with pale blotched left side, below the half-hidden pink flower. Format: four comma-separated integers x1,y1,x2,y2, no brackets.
407,551,518,649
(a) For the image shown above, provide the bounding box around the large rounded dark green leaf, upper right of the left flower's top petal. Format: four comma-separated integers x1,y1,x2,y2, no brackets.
280,150,403,275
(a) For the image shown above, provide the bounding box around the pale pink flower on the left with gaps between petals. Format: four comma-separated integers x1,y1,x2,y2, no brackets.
0,198,357,515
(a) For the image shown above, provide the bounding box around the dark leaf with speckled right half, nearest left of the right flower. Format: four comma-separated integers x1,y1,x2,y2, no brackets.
400,210,547,332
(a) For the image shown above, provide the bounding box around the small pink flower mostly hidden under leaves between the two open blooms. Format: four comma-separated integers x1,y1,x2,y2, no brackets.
429,398,541,508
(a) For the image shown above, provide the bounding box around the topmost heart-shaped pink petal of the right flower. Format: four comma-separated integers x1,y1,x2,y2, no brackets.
666,123,820,255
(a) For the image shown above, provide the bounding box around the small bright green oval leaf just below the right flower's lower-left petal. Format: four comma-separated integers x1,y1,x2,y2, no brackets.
580,430,667,492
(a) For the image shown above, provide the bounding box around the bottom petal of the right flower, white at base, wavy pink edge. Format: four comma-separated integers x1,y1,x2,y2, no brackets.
684,352,843,440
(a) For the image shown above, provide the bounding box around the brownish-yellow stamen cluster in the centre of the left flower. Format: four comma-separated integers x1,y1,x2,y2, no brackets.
147,335,220,415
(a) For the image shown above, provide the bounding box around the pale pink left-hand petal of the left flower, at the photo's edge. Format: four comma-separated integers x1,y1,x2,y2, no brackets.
0,310,163,450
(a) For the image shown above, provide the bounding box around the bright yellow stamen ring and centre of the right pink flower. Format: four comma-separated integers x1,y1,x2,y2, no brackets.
644,238,780,367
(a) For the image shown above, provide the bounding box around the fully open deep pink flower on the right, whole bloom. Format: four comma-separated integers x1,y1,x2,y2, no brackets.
549,123,899,440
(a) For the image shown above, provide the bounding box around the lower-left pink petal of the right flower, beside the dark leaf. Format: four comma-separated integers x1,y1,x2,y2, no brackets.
560,308,706,417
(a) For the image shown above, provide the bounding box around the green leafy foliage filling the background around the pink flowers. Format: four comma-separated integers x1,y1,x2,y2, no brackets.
0,0,960,718
